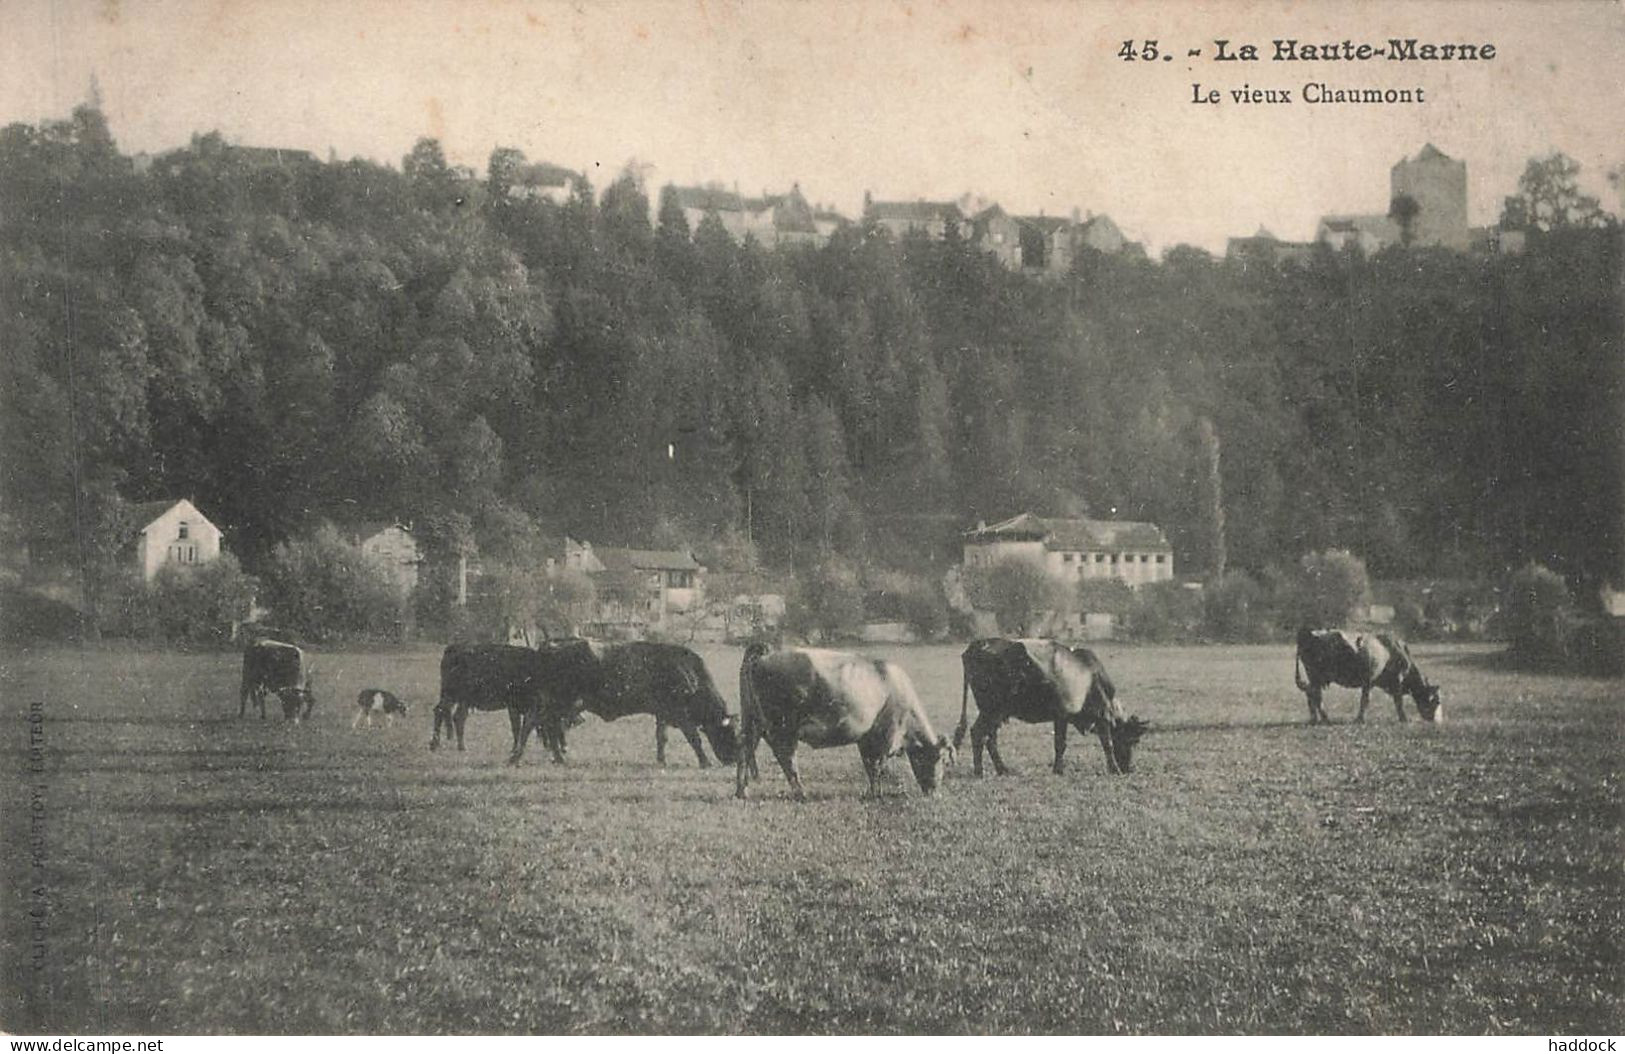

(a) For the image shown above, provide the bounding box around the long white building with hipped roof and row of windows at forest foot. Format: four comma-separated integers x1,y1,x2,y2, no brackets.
960,513,1173,586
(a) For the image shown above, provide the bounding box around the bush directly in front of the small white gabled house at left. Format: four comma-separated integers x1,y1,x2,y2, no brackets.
99,552,255,645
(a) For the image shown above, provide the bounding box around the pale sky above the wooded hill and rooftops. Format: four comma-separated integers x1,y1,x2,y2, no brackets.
0,0,1625,252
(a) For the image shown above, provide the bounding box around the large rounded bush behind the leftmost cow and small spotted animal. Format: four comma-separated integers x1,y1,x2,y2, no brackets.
265,526,406,640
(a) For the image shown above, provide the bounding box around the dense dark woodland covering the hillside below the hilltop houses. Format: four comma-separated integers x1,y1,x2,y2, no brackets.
0,107,1622,607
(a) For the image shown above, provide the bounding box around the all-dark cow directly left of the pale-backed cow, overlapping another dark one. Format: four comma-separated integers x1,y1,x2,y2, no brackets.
518,640,738,768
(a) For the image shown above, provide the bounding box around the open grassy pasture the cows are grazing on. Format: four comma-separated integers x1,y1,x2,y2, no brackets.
0,636,1625,1033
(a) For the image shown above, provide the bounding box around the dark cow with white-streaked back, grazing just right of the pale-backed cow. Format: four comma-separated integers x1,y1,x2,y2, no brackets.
954,637,1147,776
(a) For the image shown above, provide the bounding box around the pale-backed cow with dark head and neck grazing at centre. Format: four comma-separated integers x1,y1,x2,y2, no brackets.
735,645,954,801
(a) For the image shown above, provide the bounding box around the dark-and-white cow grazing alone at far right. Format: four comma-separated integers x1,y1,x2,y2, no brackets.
1292,629,1445,724
